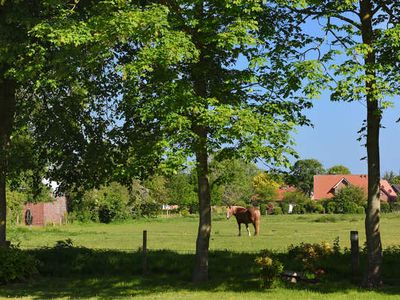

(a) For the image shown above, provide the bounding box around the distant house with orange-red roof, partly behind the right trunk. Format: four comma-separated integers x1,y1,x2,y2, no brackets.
313,175,397,202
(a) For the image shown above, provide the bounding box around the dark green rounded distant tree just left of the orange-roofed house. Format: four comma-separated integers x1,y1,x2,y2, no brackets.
287,159,325,196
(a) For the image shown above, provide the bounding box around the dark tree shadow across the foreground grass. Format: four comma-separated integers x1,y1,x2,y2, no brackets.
0,247,400,299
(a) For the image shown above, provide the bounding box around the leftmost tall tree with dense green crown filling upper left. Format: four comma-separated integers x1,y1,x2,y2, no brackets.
0,0,194,245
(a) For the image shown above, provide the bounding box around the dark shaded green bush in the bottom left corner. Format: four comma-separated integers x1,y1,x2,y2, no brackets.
0,246,39,284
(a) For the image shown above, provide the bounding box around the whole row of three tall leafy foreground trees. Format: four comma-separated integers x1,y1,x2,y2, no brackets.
0,0,400,287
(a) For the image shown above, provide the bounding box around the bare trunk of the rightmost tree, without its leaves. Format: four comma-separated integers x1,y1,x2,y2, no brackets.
360,0,382,288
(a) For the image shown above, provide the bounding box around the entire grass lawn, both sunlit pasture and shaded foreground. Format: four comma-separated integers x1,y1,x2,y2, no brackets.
0,214,400,299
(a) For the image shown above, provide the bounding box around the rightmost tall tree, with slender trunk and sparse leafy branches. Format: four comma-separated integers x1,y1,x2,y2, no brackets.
287,0,400,288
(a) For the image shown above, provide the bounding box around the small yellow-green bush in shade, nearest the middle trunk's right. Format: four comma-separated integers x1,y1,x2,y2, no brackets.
255,250,283,289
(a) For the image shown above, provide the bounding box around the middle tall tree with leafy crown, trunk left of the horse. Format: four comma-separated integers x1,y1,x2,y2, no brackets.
117,0,308,282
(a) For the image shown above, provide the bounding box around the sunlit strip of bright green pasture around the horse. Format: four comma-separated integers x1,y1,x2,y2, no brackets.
8,213,400,252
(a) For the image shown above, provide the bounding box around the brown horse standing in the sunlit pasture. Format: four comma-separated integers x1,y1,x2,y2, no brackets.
226,206,260,236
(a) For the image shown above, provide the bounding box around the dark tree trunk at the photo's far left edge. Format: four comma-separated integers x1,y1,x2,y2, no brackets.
0,71,15,247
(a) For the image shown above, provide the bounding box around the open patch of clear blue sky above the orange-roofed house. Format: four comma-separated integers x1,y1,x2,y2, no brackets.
295,95,400,176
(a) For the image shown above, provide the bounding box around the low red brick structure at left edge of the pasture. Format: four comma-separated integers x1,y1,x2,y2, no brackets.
23,196,67,226
